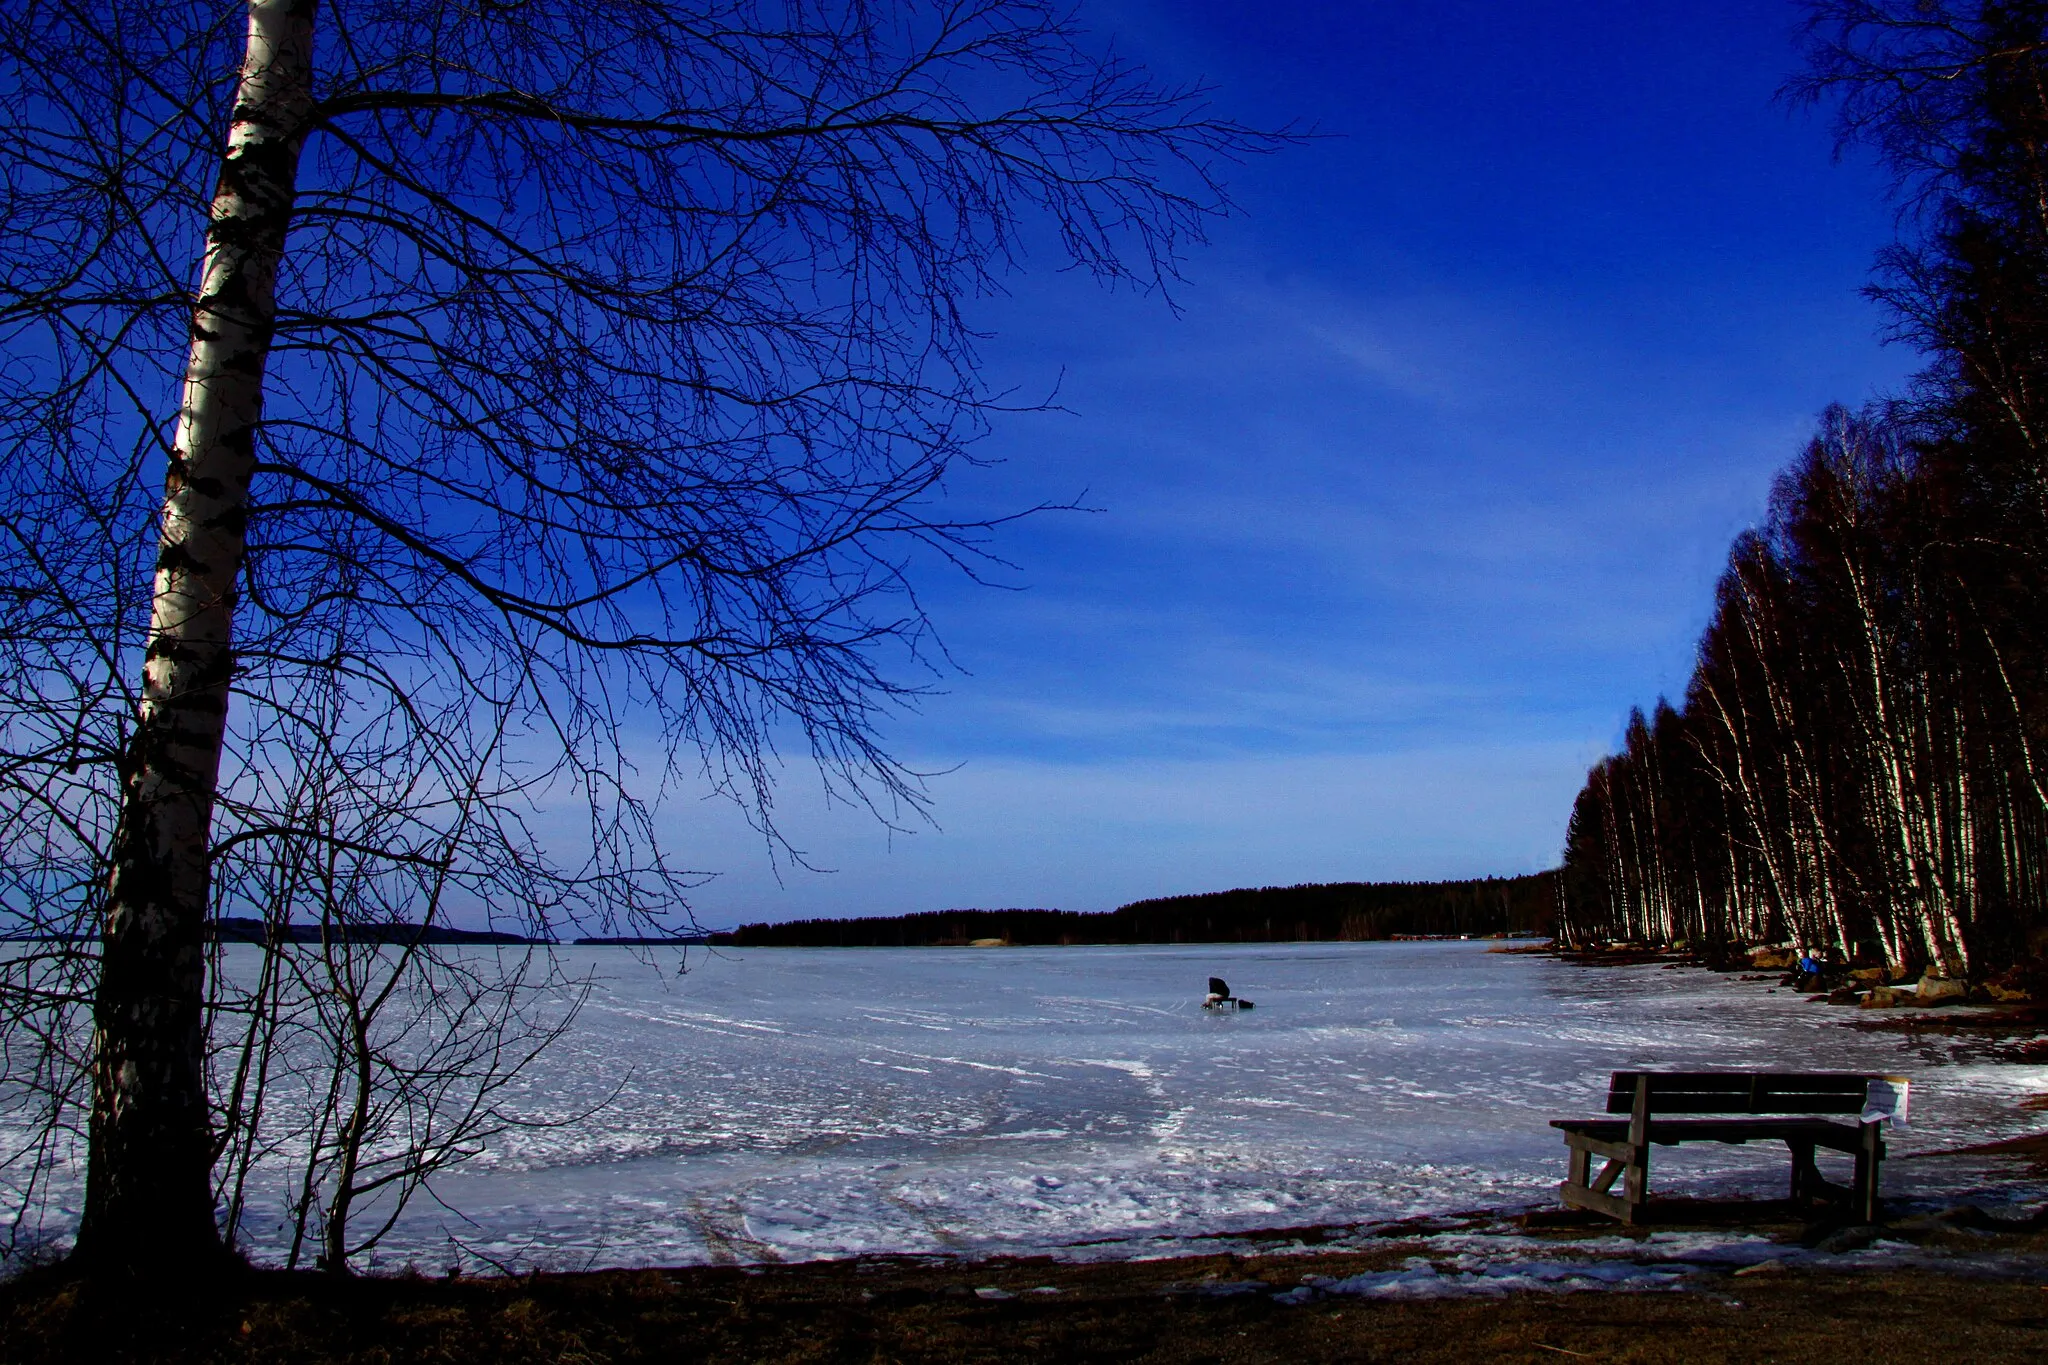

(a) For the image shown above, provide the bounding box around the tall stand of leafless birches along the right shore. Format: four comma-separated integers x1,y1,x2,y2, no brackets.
1561,4,2048,976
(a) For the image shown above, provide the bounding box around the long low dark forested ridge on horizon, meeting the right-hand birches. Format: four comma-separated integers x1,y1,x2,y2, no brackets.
711,872,1556,948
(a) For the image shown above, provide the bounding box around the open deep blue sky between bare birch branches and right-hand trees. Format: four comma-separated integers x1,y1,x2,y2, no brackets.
672,0,1915,923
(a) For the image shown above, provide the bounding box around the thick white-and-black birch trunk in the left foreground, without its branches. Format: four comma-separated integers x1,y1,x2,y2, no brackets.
78,0,313,1265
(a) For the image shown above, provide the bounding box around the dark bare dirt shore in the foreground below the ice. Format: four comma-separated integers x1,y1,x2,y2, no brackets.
0,1205,2048,1365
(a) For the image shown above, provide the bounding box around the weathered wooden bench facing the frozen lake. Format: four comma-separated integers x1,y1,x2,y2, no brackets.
1550,1070,1905,1224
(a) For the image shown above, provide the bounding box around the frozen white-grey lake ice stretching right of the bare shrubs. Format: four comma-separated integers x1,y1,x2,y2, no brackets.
4,943,2048,1268
